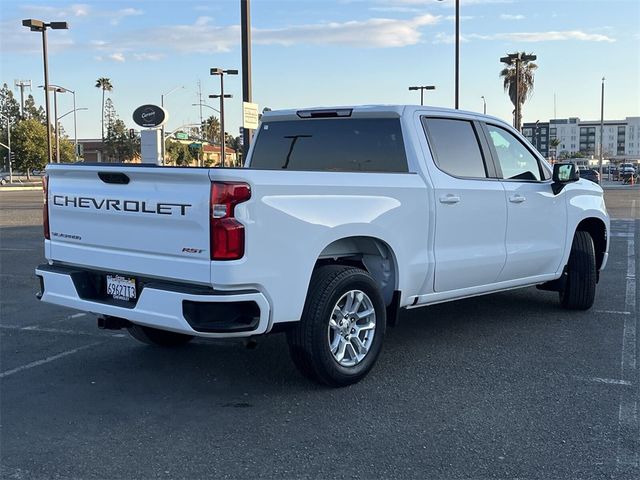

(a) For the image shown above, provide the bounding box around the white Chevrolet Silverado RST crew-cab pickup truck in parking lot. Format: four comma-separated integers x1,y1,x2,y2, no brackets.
36,105,609,386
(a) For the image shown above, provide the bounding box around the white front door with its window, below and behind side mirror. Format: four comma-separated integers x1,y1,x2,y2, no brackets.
486,124,567,281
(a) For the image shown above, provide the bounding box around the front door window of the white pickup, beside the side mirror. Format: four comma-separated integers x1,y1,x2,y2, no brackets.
487,125,541,180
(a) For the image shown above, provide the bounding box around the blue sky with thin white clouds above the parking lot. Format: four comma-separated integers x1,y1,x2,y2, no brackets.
0,0,640,138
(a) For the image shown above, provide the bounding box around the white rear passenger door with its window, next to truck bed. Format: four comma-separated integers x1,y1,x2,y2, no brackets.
422,116,507,292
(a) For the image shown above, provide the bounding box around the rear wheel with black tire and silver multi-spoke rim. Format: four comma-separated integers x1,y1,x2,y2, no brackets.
287,265,386,387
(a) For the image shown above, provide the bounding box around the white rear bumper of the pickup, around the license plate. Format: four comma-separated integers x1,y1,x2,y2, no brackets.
36,265,271,338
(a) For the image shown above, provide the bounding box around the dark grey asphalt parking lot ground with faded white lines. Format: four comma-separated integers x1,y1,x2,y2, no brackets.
0,188,640,479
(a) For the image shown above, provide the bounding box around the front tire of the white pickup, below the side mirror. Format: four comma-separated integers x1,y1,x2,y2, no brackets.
560,231,596,310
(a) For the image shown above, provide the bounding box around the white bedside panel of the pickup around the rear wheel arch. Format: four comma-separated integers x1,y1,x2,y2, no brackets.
211,169,429,322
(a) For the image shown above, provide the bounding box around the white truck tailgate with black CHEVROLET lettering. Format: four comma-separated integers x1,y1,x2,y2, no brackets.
45,164,211,284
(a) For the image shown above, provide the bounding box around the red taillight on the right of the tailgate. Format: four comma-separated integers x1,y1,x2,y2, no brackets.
209,182,251,260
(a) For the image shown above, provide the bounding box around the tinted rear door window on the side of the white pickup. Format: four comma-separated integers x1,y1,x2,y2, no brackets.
423,118,487,178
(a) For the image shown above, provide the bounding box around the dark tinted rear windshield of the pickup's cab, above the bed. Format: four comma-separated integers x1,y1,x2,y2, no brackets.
251,118,408,172
